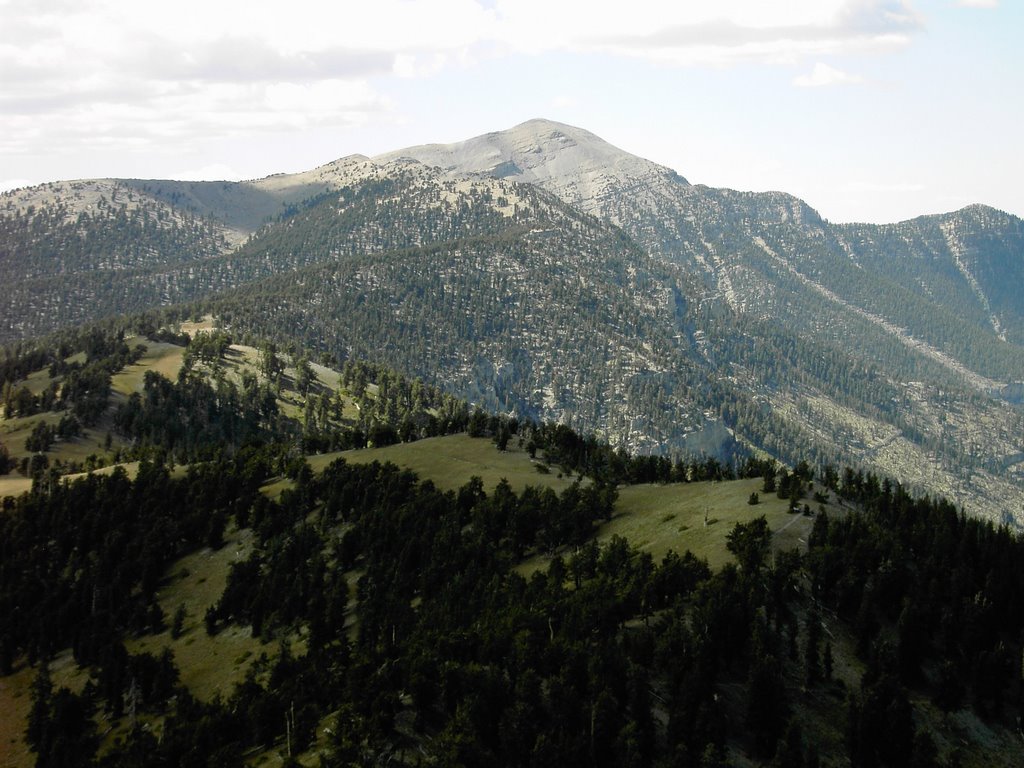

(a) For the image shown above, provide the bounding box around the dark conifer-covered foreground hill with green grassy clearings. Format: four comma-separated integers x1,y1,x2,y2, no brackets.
0,324,1024,768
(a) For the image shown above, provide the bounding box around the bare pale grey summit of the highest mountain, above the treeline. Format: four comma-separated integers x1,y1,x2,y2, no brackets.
374,118,688,213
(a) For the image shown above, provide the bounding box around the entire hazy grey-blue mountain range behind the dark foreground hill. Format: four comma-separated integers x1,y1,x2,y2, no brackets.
0,120,1024,521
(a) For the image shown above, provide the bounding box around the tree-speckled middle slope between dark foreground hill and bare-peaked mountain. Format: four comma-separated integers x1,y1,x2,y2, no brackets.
195,166,1024,519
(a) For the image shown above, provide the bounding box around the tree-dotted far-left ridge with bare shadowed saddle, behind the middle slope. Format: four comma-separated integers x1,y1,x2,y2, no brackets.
0,157,389,342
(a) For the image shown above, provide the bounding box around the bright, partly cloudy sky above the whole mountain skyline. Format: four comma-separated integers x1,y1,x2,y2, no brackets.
0,0,1024,223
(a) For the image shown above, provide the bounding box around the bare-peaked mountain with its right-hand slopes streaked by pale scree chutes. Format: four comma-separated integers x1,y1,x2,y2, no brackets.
364,120,1024,528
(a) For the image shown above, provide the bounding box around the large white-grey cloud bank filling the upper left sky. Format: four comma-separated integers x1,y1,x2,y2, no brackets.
0,0,494,163
